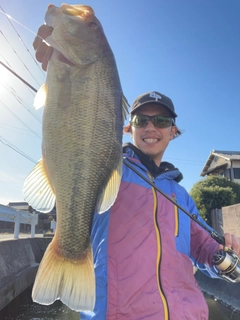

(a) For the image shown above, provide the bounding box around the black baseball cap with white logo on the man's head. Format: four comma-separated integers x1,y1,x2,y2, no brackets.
130,91,177,118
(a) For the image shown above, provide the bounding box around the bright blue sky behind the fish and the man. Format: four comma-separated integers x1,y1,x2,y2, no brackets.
0,0,240,204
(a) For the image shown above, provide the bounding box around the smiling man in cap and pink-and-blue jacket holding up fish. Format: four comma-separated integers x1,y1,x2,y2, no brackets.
34,26,240,320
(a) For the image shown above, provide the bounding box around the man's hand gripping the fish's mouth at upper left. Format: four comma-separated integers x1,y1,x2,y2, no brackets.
33,24,53,71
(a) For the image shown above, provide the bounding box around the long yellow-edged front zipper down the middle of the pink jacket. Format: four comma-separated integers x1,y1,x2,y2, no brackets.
148,174,170,320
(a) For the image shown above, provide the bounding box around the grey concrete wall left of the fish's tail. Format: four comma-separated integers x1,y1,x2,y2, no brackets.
0,238,52,310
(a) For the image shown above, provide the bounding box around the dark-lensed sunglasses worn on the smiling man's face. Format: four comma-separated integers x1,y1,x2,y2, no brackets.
130,114,174,128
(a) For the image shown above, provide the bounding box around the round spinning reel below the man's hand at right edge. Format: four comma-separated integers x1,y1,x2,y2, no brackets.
212,247,240,283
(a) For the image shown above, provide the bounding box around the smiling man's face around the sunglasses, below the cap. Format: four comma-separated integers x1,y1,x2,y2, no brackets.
131,104,177,166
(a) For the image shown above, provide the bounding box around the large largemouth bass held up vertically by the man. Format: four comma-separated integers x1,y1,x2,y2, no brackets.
23,4,128,311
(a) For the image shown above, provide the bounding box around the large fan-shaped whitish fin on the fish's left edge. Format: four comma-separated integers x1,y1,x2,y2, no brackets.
23,159,55,213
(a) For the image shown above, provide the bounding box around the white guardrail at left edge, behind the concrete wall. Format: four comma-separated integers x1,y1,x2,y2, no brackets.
0,204,38,239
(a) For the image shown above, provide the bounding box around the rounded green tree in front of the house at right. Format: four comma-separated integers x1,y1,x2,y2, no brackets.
189,176,240,225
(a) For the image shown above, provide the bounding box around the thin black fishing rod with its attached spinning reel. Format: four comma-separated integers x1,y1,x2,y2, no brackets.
123,159,240,283
